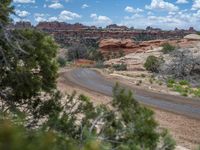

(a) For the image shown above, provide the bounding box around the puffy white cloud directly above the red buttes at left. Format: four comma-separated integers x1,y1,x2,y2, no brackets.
58,10,81,21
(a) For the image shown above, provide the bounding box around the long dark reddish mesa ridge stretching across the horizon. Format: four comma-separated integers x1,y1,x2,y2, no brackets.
9,21,196,48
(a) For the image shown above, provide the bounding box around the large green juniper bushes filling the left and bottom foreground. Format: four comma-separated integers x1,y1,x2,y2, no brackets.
0,0,175,150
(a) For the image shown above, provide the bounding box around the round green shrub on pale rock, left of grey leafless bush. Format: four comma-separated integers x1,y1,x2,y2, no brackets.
144,55,161,73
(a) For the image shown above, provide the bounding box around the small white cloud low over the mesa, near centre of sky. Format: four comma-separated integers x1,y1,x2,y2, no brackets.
90,14,112,26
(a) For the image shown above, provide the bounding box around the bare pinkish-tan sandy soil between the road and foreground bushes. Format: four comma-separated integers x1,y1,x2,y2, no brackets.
58,70,200,150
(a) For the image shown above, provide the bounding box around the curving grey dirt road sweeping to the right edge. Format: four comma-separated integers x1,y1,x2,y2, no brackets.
61,68,200,119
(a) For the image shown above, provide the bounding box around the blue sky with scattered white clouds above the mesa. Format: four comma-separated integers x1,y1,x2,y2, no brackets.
12,0,200,30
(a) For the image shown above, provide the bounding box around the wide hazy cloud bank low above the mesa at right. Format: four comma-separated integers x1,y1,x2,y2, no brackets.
120,10,200,30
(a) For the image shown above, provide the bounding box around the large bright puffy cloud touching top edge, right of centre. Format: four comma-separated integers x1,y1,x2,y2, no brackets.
145,0,179,11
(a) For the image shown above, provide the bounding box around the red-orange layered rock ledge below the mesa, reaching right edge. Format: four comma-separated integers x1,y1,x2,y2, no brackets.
99,34,200,56
